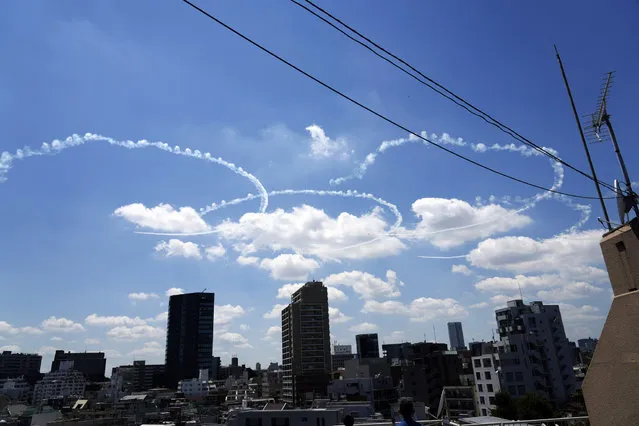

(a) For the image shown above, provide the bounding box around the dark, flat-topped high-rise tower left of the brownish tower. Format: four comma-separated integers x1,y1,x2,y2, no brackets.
165,293,215,389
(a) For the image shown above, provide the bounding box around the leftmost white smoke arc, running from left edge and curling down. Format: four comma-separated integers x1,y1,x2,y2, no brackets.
0,133,268,212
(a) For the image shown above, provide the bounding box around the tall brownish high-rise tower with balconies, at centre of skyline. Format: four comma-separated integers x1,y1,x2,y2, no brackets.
282,281,331,404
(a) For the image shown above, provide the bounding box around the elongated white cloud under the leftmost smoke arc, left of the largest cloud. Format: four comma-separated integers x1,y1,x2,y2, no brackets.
113,203,210,233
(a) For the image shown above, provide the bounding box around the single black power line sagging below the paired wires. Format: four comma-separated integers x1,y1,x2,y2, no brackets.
182,0,615,200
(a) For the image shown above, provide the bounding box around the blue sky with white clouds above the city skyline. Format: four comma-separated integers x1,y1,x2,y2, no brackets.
0,1,639,370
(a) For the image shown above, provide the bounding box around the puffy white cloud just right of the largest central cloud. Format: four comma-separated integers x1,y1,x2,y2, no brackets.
407,198,532,249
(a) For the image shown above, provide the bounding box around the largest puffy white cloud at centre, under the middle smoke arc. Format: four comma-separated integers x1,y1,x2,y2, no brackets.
215,205,406,264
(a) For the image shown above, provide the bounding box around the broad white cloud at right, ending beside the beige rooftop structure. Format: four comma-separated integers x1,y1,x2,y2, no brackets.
468,230,604,272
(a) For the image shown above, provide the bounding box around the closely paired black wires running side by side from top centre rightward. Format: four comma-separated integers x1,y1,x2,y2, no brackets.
290,0,614,191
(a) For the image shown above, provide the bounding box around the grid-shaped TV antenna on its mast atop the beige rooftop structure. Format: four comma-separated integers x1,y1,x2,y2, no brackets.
591,71,639,224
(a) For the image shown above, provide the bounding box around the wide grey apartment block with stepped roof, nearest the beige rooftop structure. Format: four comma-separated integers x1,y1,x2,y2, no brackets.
495,300,576,405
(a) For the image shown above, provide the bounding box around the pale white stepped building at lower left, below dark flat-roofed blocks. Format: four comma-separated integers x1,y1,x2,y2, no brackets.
33,361,86,405
